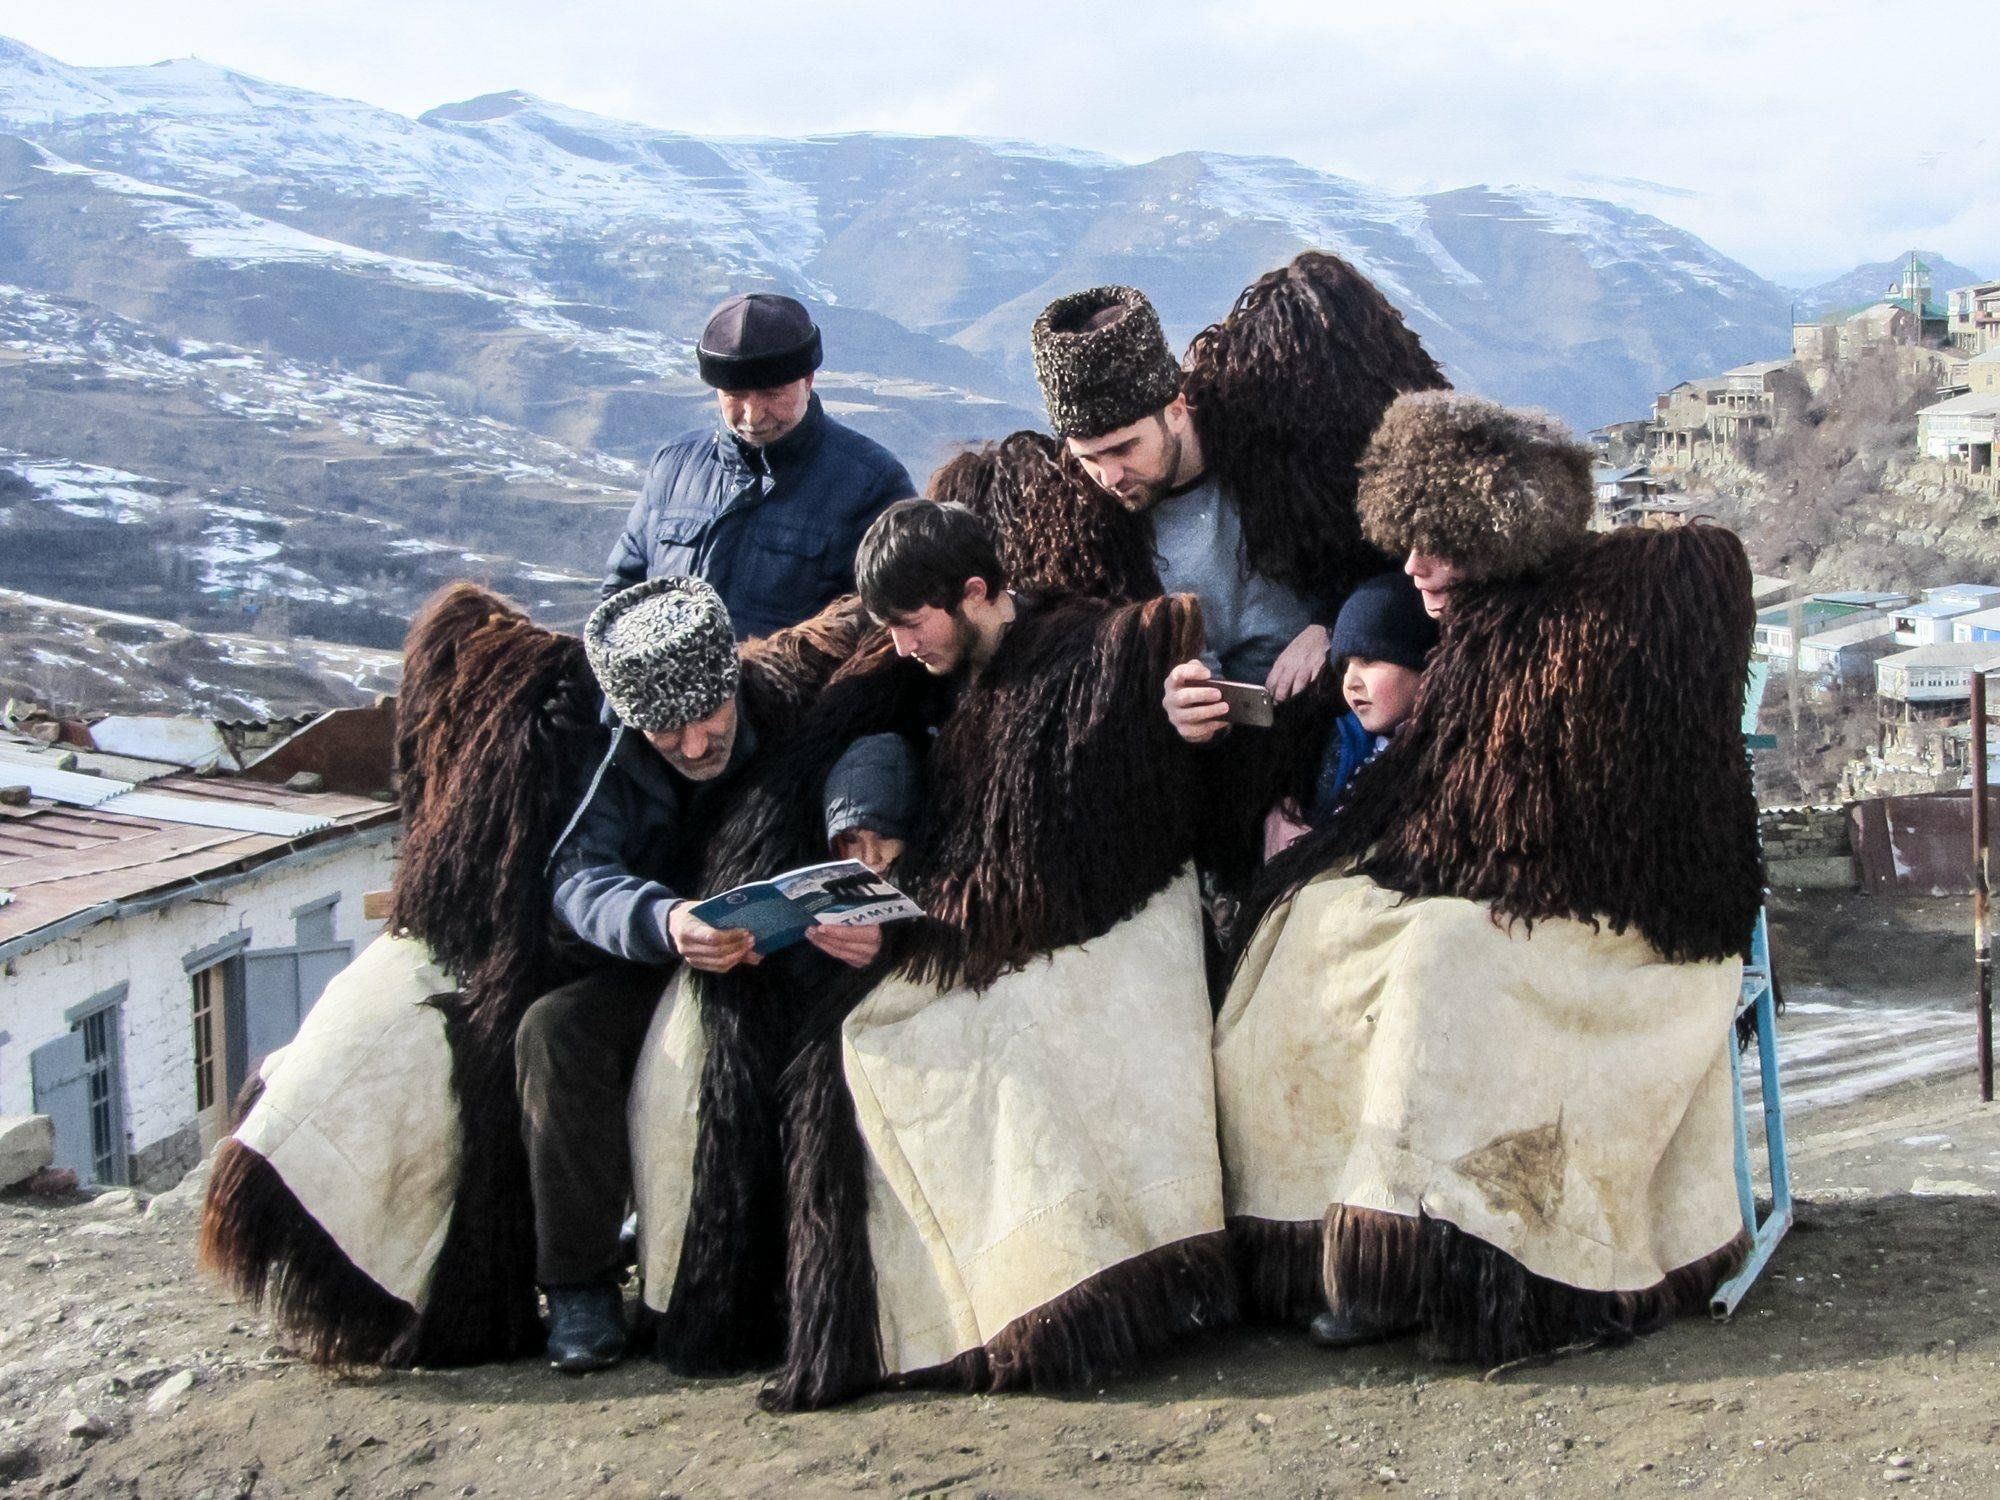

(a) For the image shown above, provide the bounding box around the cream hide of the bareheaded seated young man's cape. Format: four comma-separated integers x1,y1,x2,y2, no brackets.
632,874,1222,1374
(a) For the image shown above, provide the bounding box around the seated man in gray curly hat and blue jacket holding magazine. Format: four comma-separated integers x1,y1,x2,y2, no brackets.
514,578,882,1372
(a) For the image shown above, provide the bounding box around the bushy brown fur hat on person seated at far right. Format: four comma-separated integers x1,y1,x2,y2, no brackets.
1358,390,1594,578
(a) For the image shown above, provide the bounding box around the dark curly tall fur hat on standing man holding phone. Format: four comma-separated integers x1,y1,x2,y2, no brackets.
1030,286,1180,438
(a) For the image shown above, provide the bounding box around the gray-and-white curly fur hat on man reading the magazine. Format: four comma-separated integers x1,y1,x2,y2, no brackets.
584,576,740,730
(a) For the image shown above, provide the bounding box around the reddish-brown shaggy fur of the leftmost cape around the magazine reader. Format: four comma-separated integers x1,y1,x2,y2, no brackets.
200,582,862,1366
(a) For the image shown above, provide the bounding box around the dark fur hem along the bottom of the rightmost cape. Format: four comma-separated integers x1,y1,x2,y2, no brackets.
1326,1204,1748,1368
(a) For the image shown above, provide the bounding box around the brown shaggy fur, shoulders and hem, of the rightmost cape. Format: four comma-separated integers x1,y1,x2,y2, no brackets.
1230,526,1764,1364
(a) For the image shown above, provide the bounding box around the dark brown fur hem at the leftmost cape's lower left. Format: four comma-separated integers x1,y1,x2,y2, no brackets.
196,1140,416,1366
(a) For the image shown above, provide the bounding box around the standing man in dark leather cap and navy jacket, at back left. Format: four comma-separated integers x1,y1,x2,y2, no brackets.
604,292,916,638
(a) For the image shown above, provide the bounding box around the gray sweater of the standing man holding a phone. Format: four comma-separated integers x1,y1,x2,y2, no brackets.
1148,476,1314,682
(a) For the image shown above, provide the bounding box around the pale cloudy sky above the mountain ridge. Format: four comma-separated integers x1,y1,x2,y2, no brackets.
0,0,2000,286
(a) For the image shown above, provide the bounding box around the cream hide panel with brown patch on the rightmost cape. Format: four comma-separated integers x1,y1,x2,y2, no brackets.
1216,876,1742,1292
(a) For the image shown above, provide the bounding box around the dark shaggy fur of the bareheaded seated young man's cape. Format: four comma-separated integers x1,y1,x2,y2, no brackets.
658,598,1230,1408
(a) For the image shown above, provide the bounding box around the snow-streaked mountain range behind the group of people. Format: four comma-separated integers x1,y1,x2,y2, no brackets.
0,38,1788,688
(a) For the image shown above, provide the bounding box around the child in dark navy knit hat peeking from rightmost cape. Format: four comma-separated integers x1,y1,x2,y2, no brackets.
1264,572,1438,858
